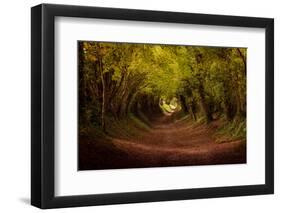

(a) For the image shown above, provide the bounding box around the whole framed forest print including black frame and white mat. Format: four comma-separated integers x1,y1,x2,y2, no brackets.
31,4,274,208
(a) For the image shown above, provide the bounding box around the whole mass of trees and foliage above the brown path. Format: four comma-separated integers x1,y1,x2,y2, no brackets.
78,41,246,140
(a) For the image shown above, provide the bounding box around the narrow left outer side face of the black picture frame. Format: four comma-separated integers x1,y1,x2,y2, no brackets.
31,5,42,208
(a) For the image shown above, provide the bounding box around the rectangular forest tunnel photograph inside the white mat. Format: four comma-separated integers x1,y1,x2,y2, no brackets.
77,40,247,170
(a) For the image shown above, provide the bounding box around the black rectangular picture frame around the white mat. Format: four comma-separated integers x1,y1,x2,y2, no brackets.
31,4,274,209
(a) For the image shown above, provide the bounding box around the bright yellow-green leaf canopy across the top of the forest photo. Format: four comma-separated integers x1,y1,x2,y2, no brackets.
79,42,247,106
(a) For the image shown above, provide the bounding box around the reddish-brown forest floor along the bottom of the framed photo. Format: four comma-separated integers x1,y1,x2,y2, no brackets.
79,114,246,170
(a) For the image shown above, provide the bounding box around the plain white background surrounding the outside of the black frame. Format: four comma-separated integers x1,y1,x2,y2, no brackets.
0,0,281,213
